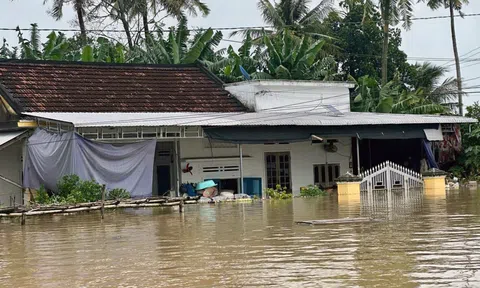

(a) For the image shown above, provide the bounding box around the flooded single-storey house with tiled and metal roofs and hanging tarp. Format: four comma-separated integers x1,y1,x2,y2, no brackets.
0,61,474,205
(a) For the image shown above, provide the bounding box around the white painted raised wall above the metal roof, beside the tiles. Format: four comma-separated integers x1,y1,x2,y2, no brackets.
225,80,353,112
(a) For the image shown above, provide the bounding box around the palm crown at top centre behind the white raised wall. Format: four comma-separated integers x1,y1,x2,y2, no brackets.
231,0,334,38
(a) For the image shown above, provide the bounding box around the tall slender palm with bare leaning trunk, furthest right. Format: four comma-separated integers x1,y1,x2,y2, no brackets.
424,0,468,115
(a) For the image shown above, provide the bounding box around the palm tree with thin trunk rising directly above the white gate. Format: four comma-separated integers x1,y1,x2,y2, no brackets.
365,0,414,85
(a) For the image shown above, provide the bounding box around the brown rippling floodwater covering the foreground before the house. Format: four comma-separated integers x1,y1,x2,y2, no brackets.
0,191,480,287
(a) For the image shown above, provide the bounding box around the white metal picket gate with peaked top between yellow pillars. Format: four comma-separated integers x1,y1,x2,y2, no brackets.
360,161,423,192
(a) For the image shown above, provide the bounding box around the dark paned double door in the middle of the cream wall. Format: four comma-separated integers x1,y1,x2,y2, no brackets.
265,152,292,191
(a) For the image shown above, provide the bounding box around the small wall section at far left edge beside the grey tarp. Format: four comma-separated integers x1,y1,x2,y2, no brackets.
0,141,25,206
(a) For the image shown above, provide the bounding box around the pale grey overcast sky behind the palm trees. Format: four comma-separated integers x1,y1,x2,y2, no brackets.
0,0,480,105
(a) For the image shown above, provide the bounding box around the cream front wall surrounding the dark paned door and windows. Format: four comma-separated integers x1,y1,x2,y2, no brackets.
180,138,351,195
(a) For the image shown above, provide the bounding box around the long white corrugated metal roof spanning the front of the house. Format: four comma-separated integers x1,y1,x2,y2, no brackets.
24,112,476,127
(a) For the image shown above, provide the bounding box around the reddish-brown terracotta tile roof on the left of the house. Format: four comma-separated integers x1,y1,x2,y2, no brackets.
0,61,246,112
